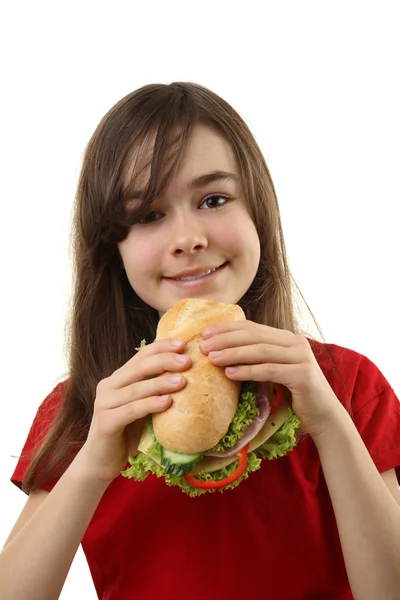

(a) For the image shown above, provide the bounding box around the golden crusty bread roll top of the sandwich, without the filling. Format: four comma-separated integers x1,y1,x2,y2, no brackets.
153,298,246,454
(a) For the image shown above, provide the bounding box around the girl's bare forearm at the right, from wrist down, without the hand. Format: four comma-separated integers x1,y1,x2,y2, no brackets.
313,406,400,600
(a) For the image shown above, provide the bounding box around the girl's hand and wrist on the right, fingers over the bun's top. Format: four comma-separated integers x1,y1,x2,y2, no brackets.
200,321,343,436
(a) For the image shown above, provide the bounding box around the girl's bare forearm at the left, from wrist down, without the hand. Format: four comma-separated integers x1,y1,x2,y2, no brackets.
0,454,109,600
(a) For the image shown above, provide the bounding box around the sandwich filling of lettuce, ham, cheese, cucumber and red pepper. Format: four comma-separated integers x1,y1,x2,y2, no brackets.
121,382,300,497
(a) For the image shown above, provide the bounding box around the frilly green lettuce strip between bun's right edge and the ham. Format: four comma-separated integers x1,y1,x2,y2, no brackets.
207,381,260,452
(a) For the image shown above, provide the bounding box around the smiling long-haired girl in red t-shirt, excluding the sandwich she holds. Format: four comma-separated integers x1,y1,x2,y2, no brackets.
0,83,400,600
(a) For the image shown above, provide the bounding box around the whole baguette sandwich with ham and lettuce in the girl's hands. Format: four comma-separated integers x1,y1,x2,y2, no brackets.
122,298,300,497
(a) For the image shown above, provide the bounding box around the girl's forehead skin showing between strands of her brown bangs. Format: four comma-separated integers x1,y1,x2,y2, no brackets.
124,124,238,189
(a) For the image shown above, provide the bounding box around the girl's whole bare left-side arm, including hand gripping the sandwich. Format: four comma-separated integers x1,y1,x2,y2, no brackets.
0,339,190,600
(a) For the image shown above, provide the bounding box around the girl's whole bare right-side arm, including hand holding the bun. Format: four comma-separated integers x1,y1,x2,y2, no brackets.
201,321,400,600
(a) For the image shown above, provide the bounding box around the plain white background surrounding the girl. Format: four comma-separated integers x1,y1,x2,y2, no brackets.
0,0,400,600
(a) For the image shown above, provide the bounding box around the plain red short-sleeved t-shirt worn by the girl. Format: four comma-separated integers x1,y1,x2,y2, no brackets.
8,342,400,600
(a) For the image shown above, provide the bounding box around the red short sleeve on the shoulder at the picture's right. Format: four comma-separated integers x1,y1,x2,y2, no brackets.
353,357,400,483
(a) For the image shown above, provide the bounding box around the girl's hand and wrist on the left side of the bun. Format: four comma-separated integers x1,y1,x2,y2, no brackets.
77,339,191,482
